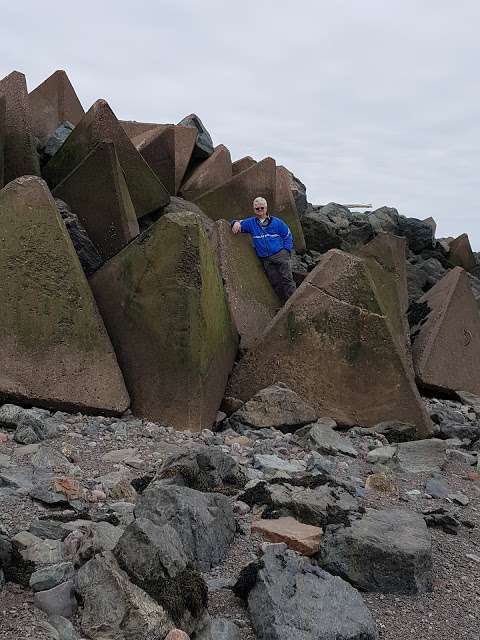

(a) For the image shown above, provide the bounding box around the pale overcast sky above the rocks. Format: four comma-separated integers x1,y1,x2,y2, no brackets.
0,0,480,250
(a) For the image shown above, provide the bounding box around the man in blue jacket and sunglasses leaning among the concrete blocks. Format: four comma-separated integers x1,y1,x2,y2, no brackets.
231,198,296,304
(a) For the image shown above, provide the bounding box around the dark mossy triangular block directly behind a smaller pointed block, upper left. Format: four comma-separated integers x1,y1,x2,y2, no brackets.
43,100,169,218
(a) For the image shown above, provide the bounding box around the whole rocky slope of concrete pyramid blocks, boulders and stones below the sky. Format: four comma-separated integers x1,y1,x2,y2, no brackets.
0,71,480,640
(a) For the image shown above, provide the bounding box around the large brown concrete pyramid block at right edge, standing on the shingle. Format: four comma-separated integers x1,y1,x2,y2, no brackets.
412,267,480,395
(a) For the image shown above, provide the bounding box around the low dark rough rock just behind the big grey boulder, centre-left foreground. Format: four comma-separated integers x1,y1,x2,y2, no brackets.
155,446,247,494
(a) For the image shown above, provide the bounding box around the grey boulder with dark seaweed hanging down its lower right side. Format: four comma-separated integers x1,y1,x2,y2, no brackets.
114,518,208,634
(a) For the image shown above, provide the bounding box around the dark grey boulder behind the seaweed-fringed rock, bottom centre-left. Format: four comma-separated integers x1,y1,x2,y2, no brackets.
135,482,235,571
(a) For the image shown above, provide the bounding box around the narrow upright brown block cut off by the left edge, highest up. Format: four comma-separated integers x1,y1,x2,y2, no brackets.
0,71,40,184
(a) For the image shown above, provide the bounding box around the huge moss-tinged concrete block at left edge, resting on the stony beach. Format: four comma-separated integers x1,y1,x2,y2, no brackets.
0,176,129,414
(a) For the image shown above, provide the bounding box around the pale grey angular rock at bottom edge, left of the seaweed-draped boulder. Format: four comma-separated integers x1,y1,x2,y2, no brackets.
77,552,175,640
